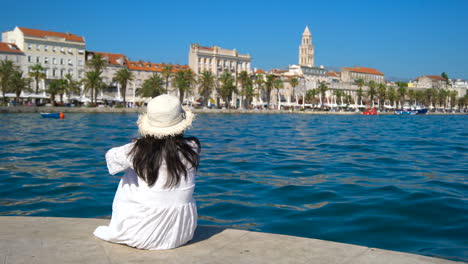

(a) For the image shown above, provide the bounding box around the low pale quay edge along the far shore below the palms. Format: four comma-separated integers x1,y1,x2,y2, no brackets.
0,106,468,115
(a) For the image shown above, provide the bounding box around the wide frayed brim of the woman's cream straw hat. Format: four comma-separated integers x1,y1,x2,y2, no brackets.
137,107,195,138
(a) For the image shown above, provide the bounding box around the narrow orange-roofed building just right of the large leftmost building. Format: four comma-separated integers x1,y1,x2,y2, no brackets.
86,51,130,101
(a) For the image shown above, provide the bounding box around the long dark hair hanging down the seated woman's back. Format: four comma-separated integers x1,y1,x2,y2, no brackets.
130,135,201,188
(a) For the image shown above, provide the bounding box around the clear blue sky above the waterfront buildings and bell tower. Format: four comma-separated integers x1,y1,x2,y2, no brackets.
0,0,468,79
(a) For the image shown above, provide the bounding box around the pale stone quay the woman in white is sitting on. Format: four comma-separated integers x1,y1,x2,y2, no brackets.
0,216,461,264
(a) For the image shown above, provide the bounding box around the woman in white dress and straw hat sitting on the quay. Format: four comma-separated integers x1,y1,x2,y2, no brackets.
94,95,201,250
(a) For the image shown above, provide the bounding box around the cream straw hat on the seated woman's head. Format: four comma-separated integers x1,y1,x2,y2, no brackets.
137,94,195,138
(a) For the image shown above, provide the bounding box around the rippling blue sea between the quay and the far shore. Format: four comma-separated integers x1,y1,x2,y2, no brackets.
0,113,468,261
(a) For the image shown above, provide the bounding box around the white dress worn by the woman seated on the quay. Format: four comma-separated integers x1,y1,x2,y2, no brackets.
94,142,199,250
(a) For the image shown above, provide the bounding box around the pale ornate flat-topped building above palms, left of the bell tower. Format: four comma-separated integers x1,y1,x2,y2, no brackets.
189,44,252,77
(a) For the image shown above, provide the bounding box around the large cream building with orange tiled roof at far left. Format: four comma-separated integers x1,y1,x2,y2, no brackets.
2,27,86,92
